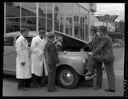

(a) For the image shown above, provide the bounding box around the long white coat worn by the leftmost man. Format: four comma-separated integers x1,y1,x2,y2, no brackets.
15,35,31,79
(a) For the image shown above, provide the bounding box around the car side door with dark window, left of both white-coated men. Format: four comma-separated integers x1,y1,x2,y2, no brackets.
3,36,16,71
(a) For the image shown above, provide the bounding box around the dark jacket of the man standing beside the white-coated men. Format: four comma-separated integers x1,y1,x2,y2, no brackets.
44,40,59,69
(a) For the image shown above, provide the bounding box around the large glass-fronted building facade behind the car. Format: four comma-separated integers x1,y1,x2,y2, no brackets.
4,2,96,41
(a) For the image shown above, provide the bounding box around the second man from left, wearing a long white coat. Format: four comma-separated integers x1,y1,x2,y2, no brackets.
31,30,45,88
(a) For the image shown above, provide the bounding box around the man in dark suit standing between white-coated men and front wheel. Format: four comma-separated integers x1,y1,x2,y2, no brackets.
45,32,59,92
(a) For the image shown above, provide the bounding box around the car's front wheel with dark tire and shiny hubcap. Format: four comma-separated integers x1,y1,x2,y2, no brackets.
57,67,79,89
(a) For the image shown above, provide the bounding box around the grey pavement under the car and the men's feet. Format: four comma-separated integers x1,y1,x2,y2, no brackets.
2,48,124,97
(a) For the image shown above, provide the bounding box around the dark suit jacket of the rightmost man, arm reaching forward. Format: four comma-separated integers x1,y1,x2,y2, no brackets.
92,35,115,63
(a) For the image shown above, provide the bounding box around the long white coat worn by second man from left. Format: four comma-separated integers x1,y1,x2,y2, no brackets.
31,36,44,76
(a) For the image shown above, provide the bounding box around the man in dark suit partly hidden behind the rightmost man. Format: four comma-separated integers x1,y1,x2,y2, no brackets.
85,26,102,89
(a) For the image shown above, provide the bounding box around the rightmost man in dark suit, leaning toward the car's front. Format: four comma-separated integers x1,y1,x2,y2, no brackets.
86,26,115,92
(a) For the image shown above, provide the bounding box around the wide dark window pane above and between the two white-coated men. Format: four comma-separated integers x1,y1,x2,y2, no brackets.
21,17,36,31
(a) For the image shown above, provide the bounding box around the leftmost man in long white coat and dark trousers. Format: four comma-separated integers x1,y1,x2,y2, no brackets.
15,28,31,90
